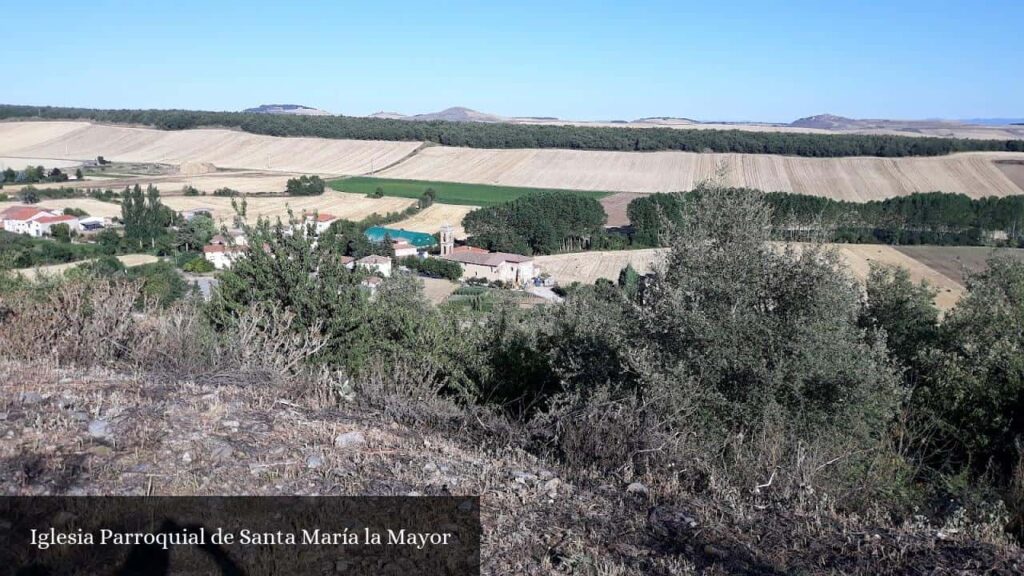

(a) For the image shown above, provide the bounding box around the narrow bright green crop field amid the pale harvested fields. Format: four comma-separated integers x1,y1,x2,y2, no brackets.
327,176,612,206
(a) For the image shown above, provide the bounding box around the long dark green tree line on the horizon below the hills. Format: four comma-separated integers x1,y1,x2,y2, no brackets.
0,105,1024,157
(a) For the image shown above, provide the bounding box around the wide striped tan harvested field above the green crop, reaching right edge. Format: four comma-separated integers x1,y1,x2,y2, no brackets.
377,147,1024,201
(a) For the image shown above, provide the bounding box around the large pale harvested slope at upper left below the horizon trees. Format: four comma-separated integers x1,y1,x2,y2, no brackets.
0,122,420,175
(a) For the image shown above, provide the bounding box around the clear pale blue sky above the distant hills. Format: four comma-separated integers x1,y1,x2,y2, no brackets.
0,0,1024,122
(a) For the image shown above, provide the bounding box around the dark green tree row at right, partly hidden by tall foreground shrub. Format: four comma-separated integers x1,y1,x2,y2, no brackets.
627,189,1024,246
